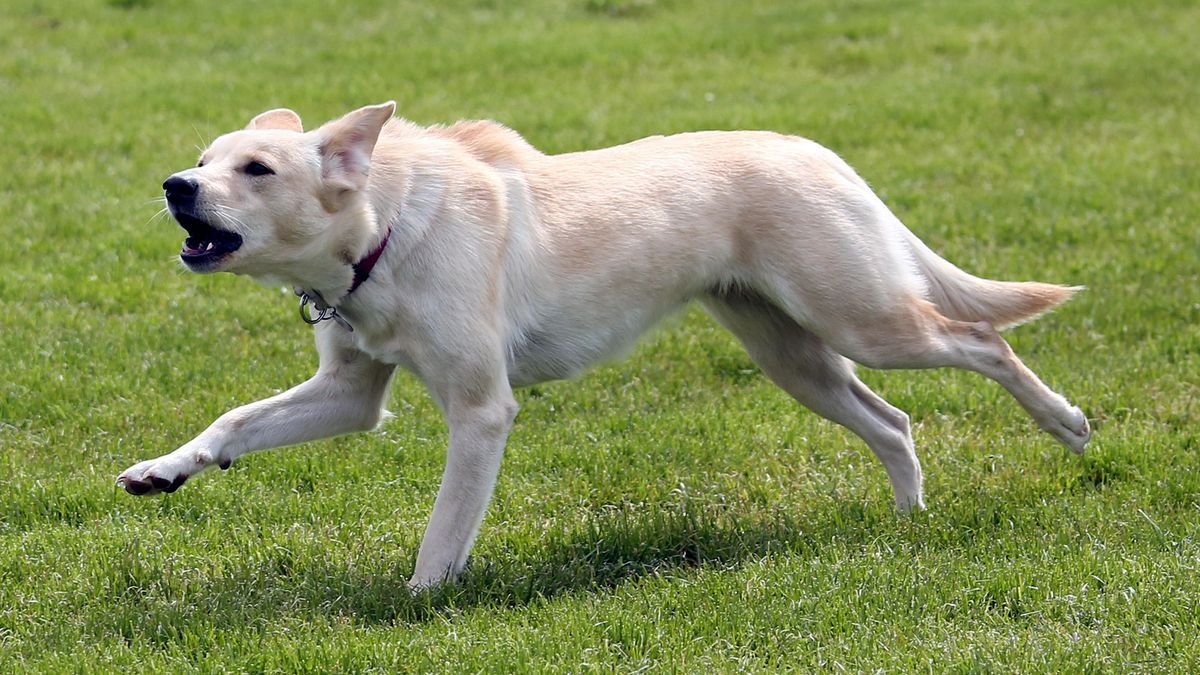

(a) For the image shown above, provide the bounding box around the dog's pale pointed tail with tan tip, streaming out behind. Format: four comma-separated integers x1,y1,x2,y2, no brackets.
905,229,1084,329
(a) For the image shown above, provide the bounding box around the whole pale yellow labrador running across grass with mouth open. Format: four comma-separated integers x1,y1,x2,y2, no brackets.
118,102,1091,587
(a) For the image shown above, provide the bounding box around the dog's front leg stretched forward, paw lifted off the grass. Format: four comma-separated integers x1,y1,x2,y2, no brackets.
116,324,395,495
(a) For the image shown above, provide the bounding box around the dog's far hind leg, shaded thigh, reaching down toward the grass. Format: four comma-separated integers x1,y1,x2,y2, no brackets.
703,291,925,510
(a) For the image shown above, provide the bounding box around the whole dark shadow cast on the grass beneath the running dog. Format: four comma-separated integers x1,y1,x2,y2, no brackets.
86,482,1070,647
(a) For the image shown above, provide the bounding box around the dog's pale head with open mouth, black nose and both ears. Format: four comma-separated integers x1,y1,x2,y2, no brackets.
162,101,396,279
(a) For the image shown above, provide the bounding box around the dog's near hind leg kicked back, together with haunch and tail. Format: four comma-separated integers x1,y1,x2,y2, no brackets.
744,184,1091,453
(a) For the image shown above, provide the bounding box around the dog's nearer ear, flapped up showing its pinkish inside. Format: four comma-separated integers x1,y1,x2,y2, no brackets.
317,101,396,191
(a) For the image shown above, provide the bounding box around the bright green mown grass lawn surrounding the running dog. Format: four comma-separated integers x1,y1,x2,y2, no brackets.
0,0,1200,671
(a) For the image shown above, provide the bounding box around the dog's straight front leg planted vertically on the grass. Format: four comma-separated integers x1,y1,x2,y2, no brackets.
409,369,517,590
